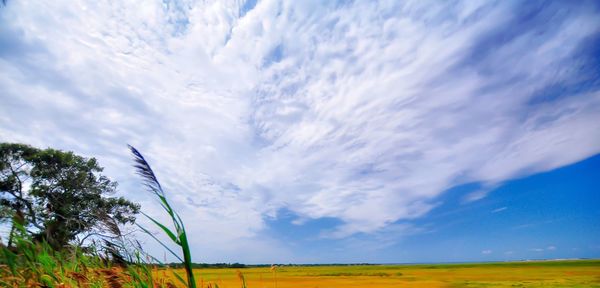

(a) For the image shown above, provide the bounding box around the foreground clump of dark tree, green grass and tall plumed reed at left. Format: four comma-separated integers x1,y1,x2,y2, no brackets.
0,143,199,288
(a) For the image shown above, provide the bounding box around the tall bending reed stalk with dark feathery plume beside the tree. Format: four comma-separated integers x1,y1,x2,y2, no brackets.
129,145,196,288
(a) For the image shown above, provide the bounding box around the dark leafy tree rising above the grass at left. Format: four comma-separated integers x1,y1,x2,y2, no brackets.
0,143,140,249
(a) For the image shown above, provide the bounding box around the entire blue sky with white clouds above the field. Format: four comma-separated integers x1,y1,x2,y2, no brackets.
0,0,600,263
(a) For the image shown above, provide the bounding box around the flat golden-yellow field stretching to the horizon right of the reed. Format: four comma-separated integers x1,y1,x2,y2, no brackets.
163,260,600,288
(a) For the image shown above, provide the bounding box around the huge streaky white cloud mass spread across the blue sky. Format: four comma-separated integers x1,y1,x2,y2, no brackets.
0,0,600,260
